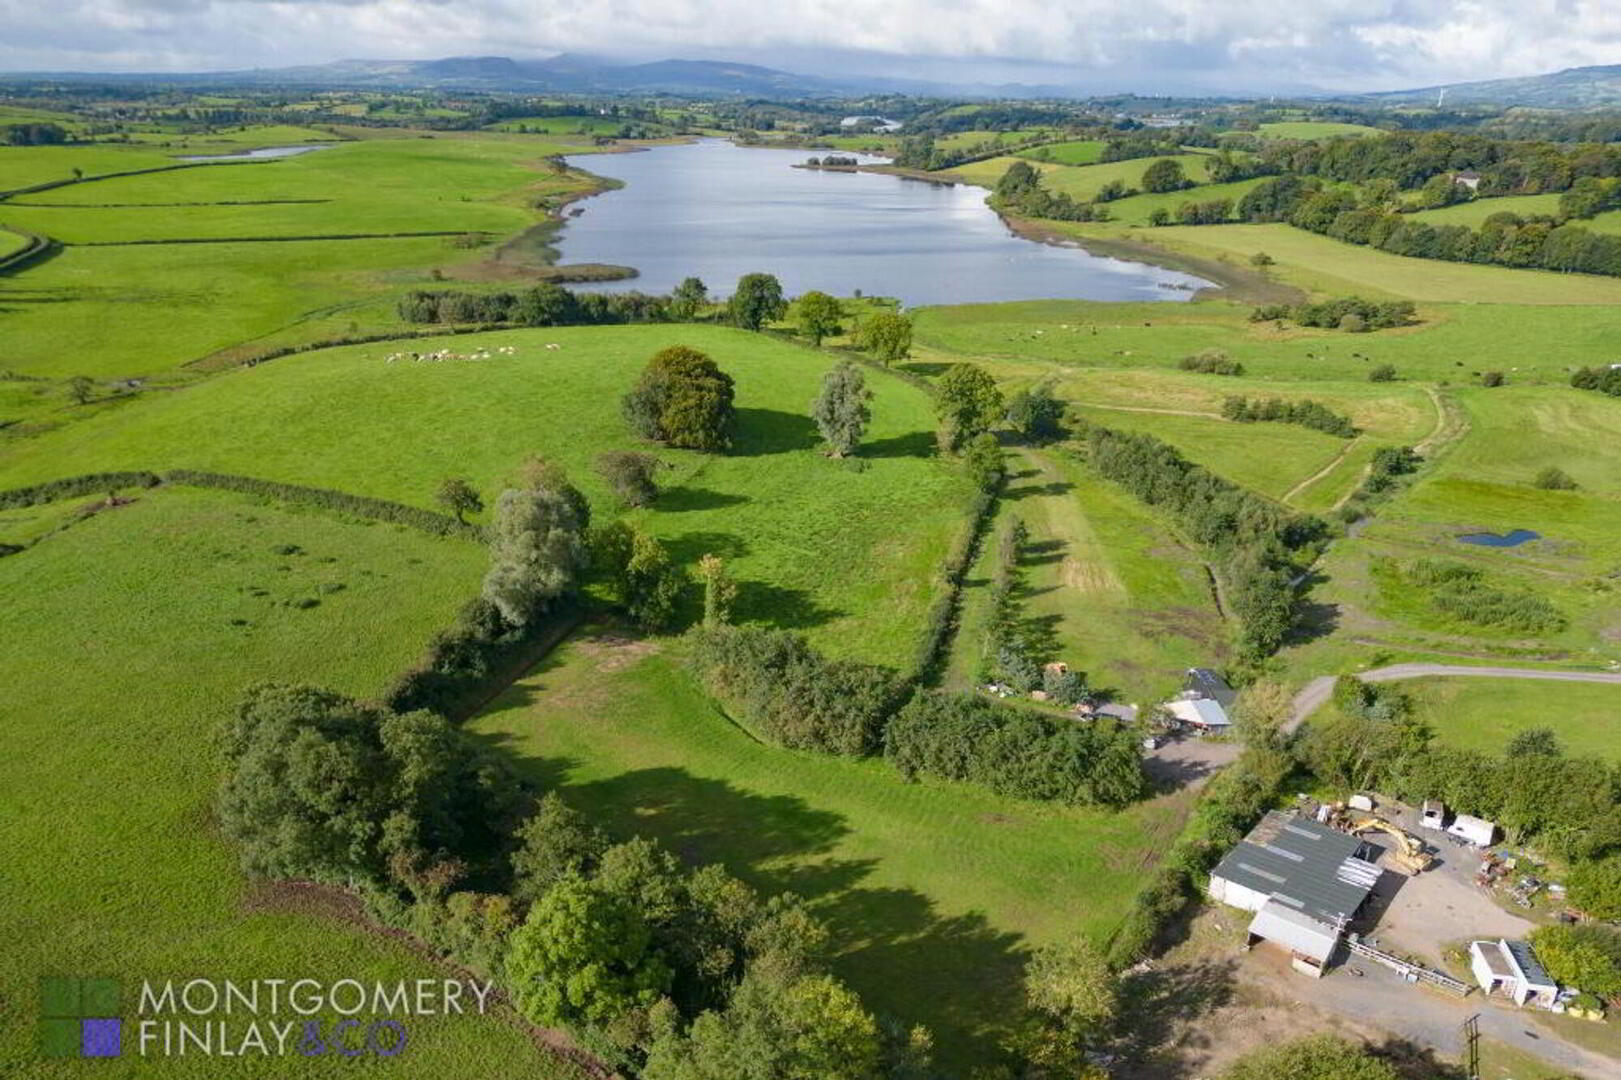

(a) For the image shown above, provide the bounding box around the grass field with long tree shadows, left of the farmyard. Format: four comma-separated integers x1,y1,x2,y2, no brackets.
468,634,1185,1075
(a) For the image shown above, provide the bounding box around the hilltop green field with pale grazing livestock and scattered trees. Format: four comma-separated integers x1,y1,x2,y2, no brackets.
0,326,968,665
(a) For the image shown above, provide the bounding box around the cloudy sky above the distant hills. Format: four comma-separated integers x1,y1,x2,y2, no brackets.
0,0,1621,91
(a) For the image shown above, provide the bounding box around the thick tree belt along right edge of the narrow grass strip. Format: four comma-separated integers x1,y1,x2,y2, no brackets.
1083,423,1328,660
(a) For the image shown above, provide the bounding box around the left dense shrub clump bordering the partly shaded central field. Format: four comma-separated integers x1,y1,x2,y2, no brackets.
692,626,903,756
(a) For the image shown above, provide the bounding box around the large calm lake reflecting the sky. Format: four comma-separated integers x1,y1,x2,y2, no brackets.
558,139,1209,305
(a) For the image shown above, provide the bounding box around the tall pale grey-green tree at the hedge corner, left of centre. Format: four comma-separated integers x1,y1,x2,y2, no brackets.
483,461,590,626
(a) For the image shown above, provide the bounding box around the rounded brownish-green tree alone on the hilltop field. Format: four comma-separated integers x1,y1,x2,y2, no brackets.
624,345,734,451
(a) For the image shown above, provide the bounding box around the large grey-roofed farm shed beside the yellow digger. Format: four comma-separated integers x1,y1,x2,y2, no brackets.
1209,811,1379,976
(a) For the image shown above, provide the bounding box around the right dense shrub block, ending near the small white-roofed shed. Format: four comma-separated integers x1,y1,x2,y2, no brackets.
883,691,1144,806
